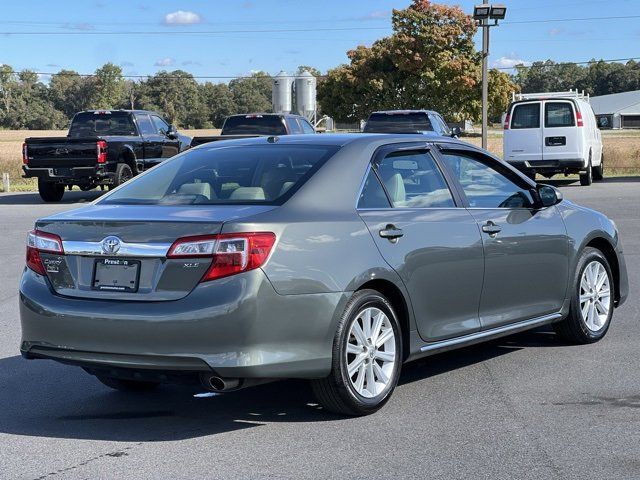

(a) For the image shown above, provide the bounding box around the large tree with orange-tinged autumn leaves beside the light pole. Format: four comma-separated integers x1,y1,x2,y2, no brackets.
318,0,516,121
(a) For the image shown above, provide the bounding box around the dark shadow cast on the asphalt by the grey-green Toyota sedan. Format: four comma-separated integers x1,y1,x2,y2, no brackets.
0,332,558,442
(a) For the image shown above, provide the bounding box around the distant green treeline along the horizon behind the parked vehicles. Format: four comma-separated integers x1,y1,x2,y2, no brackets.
0,60,640,129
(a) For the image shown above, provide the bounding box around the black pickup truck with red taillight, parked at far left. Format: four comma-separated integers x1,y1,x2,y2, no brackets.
22,110,191,202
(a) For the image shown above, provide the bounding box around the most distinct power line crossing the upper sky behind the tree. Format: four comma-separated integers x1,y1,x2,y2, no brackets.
0,15,640,36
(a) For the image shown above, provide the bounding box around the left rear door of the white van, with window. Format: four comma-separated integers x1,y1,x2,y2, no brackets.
504,101,543,163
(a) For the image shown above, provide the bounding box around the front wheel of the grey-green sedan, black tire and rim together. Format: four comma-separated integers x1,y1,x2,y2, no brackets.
553,247,615,344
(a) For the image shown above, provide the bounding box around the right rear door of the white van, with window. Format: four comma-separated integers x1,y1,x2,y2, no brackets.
542,100,582,161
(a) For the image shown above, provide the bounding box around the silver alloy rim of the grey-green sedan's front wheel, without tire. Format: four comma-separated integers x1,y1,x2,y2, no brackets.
580,260,611,332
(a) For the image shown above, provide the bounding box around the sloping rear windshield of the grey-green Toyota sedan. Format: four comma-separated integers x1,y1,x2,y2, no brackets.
99,144,339,205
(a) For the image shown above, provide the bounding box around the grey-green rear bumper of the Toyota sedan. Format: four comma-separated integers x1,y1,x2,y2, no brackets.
20,269,348,378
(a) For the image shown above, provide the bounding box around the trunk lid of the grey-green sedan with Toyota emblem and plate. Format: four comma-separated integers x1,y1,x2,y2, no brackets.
36,205,275,301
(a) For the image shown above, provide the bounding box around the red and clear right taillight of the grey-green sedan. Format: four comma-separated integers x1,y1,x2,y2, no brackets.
167,232,276,282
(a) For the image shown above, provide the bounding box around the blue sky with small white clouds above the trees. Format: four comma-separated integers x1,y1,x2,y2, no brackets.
0,0,640,81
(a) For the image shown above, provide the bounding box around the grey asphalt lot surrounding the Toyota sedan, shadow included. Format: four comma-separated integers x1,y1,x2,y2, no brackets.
0,178,640,479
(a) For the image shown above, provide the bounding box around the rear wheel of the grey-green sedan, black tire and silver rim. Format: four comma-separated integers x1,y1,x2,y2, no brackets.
311,289,403,416
